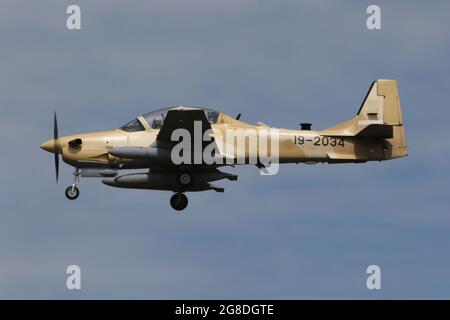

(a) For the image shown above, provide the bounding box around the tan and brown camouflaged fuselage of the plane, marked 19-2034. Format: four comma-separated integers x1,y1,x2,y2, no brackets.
41,109,386,168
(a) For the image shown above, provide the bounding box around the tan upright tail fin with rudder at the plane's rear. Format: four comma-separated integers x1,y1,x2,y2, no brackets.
323,80,408,159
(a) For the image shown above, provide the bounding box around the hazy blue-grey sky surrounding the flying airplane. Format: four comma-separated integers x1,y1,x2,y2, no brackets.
0,0,450,299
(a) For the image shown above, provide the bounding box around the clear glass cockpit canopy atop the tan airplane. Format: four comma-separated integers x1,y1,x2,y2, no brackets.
120,107,220,132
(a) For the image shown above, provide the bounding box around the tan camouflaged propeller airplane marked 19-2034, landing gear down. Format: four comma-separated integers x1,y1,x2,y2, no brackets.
40,79,408,211
